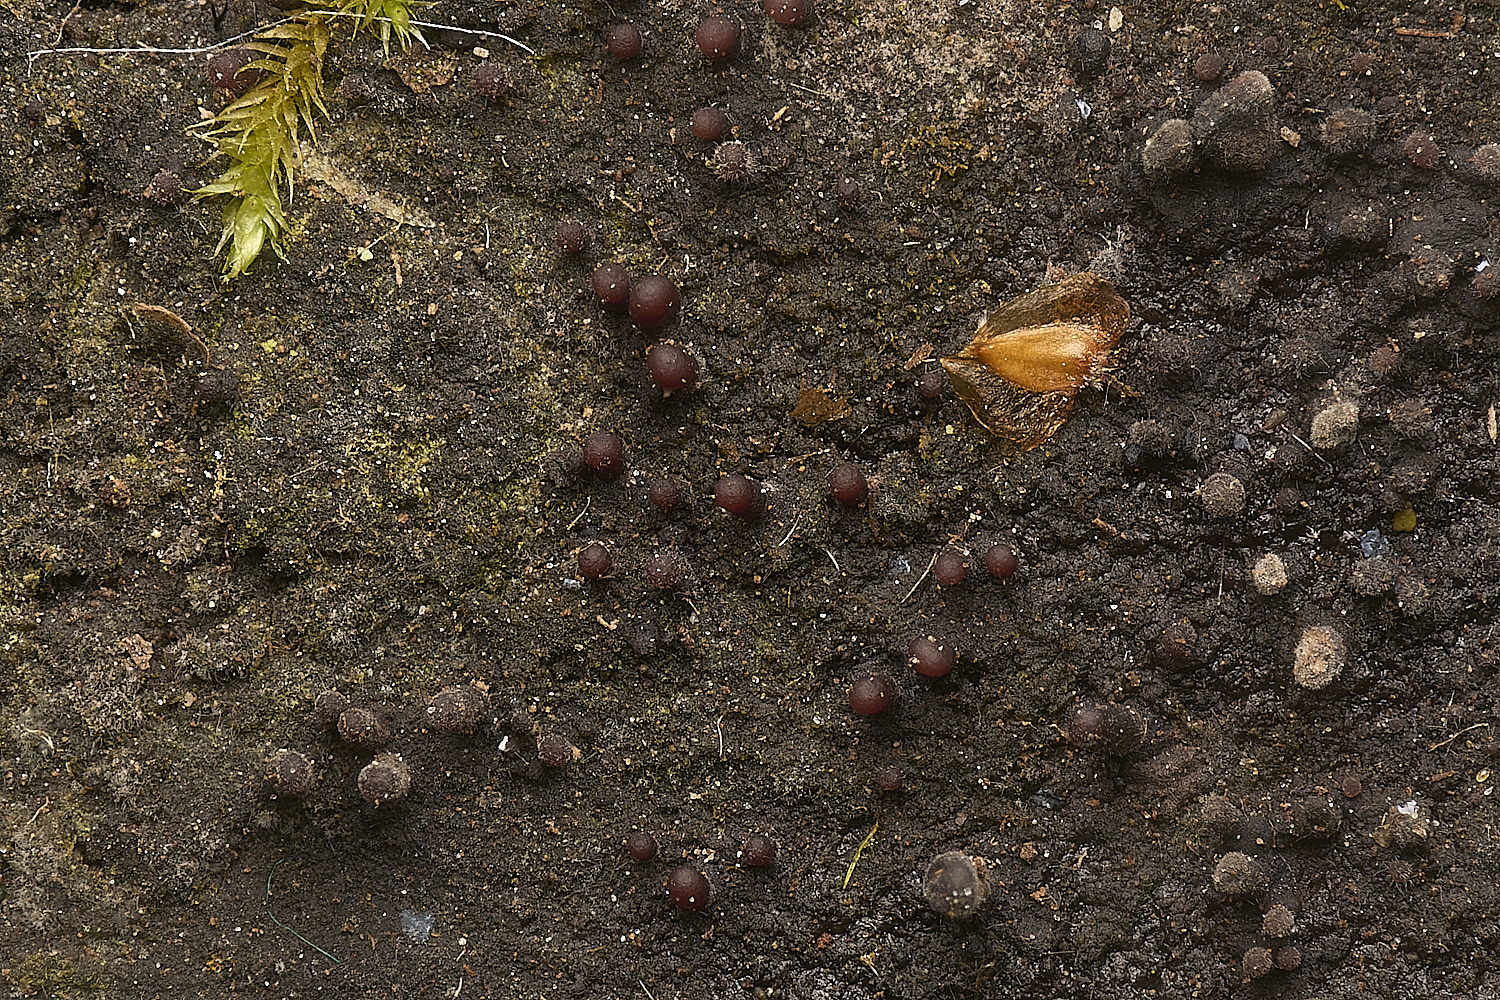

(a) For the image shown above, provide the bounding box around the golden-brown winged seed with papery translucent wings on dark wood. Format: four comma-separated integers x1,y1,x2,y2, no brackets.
942,271,1130,451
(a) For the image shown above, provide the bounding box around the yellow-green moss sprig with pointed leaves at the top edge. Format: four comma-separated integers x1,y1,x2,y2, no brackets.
194,0,423,280
